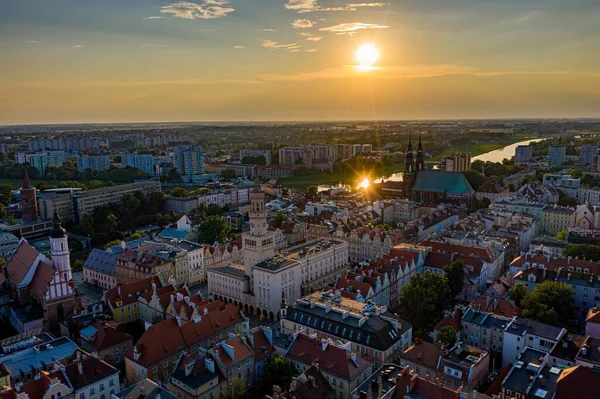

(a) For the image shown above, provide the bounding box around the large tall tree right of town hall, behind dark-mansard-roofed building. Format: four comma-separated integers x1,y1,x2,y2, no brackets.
400,271,451,336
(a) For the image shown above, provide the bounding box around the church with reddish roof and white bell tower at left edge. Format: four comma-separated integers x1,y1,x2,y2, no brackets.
0,211,81,333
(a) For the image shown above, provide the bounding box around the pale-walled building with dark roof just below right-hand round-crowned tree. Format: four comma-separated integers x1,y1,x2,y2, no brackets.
502,317,567,366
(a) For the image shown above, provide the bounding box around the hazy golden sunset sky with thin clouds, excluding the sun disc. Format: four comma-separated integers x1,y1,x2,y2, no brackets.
0,0,600,125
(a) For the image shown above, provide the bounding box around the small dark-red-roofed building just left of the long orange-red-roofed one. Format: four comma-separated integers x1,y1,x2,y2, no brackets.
79,319,133,366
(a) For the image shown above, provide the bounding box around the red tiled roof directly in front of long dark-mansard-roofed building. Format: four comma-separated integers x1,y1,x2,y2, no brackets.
286,334,371,381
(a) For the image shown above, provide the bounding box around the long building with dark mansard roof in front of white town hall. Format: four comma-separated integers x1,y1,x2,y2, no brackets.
280,290,412,365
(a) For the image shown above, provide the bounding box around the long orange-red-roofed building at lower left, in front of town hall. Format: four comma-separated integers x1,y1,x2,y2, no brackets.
125,304,249,383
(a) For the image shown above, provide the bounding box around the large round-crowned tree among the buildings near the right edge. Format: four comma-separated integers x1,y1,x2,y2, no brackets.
521,281,576,326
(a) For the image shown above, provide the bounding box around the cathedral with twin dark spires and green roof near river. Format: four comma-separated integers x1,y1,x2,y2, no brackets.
403,135,475,209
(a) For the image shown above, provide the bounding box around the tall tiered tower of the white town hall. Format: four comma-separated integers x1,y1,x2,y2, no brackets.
242,176,275,291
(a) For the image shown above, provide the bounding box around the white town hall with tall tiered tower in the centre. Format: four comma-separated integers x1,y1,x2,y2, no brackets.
207,182,348,319
